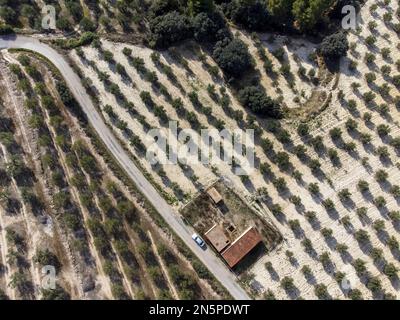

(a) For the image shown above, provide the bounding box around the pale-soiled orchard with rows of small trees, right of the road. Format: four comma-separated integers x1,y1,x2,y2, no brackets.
71,3,399,298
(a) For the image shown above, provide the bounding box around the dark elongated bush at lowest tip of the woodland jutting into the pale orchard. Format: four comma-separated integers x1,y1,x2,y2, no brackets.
239,86,283,119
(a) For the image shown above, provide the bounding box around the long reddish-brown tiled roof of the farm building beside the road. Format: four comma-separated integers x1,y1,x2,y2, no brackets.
221,227,262,268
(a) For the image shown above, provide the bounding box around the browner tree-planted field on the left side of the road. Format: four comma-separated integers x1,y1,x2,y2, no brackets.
1,53,225,299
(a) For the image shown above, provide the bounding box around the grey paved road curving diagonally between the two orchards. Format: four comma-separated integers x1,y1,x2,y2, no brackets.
0,36,250,300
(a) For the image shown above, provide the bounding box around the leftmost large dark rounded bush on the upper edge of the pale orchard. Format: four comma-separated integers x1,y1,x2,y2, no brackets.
150,11,192,48
